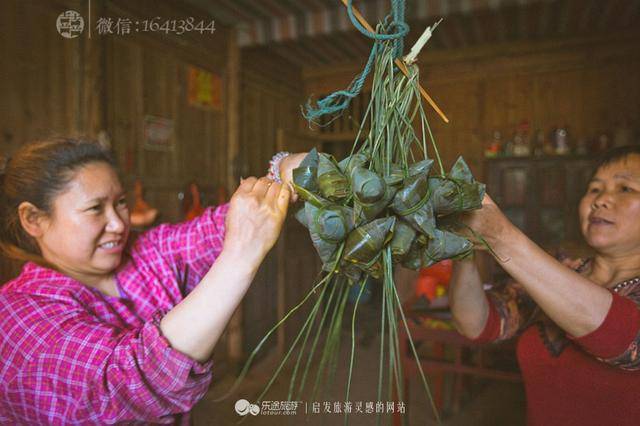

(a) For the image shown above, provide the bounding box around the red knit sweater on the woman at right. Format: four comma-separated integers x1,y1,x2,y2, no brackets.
476,294,640,426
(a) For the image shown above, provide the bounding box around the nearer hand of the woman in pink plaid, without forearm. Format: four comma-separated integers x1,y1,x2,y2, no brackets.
223,177,291,265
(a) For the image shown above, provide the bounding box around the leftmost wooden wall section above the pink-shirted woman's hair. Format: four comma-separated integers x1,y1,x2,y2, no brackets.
0,0,86,151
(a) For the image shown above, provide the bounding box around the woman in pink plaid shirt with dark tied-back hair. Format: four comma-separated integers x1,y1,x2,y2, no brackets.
0,140,304,424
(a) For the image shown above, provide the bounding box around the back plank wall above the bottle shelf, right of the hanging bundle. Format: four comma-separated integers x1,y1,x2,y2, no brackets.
304,30,640,180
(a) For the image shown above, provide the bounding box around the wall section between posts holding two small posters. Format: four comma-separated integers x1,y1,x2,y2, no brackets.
105,1,230,221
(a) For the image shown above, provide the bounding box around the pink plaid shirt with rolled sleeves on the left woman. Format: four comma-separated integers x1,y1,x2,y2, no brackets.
0,205,228,425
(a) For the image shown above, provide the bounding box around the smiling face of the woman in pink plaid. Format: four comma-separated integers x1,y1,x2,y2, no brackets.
38,162,129,285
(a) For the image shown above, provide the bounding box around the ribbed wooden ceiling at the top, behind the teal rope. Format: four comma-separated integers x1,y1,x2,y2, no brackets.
188,0,640,68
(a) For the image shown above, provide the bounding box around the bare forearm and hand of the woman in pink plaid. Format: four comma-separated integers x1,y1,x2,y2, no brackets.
160,178,290,361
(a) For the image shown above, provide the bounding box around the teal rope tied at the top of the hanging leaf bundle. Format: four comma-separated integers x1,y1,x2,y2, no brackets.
302,0,409,124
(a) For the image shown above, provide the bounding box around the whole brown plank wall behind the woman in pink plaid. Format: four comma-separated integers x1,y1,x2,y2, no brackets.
0,0,316,365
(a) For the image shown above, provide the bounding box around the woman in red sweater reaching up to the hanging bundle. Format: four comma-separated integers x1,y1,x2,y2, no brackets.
449,146,640,426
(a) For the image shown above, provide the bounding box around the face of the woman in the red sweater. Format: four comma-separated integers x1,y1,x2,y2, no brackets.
579,154,640,255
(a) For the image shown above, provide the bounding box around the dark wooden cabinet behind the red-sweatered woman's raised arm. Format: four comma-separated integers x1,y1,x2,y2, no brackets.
484,156,597,279
